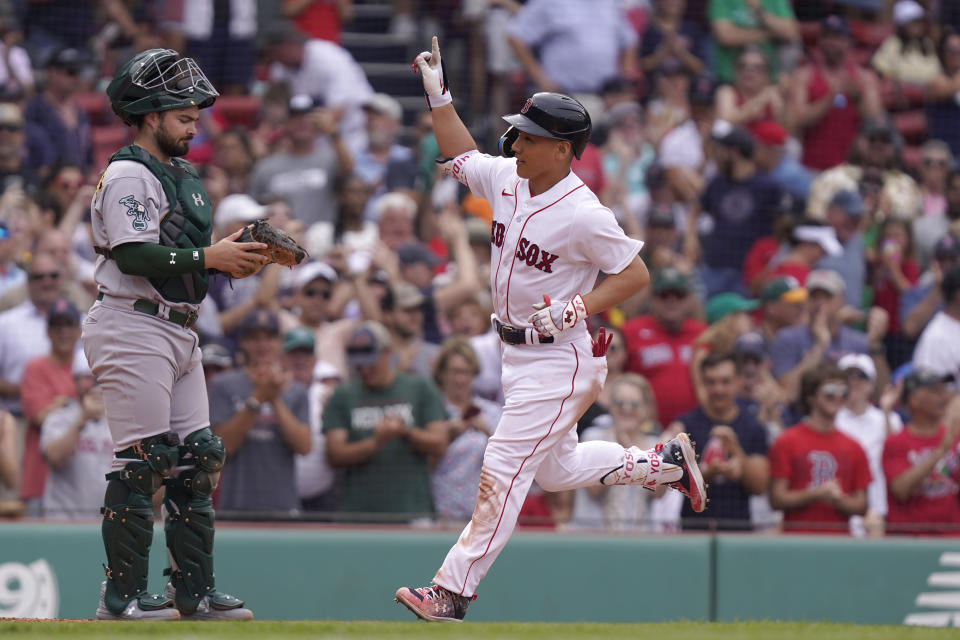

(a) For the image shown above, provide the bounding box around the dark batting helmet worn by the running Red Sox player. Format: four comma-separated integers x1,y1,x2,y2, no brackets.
500,91,591,159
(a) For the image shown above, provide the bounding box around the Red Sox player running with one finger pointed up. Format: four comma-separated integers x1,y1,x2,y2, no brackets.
396,37,706,621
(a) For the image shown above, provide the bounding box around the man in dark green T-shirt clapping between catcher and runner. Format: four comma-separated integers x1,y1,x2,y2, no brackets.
323,322,449,521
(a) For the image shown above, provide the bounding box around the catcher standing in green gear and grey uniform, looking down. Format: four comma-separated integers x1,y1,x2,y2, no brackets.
82,49,267,620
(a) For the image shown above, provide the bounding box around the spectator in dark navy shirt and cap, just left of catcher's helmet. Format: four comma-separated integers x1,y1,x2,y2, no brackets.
24,48,93,172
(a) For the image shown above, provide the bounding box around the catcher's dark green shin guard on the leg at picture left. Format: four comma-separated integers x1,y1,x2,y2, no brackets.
101,470,170,615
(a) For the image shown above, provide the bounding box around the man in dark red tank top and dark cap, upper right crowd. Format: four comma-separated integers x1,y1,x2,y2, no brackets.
788,16,883,170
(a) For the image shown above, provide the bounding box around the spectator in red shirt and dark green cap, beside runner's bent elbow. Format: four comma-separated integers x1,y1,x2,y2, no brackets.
621,267,707,424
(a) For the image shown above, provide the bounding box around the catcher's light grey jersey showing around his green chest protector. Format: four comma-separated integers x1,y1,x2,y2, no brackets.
90,160,200,311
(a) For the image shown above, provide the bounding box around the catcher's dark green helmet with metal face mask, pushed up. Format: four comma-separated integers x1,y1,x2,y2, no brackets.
107,49,220,124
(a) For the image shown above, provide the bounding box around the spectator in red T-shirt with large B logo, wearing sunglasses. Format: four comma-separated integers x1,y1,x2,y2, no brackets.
770,366,870,533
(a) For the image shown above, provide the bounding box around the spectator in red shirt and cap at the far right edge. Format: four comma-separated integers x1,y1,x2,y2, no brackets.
883,368,960,535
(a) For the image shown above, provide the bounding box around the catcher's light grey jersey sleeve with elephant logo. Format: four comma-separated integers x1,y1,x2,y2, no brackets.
93,161,167,249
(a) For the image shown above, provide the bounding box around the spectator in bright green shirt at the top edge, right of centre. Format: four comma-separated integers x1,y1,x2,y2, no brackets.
709,0,800,83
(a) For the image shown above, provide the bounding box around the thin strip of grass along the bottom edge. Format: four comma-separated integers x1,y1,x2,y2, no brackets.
0,620,957,640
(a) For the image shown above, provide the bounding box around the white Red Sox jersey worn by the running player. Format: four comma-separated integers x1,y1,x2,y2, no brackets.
450,150,643,330
